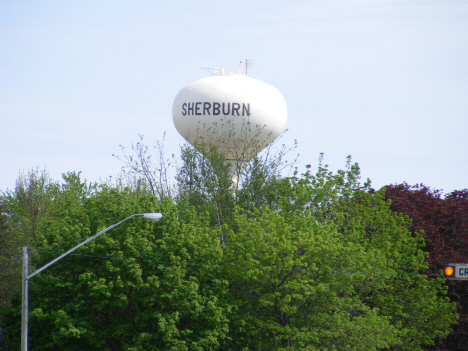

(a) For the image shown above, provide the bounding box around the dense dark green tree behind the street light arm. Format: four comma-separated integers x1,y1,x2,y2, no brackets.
3,175,230,350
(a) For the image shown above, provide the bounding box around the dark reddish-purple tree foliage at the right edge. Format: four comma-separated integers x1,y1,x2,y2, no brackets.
386,183,468,351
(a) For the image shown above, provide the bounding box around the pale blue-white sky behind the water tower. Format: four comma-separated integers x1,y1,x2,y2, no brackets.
0,0,468,192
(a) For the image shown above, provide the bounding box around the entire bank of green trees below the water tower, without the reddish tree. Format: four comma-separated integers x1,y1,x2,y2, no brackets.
0,148,457,351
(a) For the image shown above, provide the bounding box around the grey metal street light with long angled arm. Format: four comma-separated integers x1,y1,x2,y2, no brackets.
21,213,162,351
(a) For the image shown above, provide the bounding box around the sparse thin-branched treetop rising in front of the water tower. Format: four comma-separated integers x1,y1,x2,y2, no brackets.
116,133,297,228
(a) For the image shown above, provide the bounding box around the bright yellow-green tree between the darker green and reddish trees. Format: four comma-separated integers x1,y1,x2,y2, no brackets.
225,159,456,350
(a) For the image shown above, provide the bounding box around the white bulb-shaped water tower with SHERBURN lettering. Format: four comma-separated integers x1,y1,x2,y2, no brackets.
172,68,287,184
